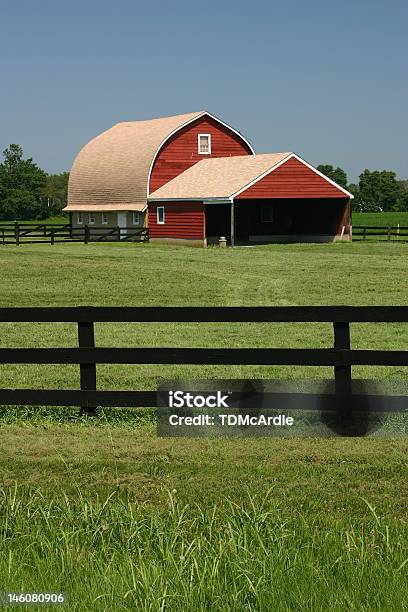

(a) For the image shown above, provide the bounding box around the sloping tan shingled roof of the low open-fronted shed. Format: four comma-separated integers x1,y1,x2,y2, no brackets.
149,152,292,201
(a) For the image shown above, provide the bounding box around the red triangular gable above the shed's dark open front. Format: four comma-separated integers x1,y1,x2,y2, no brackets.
237,157,347,200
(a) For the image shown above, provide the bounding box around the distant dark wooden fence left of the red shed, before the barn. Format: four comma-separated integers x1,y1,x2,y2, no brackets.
0,222,149,246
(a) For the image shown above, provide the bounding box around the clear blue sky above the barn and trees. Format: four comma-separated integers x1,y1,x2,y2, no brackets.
0,0,408,180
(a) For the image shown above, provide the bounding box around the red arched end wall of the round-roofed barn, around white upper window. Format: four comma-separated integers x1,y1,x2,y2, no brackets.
149,116,252,193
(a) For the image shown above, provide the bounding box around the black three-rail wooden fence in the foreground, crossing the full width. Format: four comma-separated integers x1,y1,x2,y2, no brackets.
0,306,408,411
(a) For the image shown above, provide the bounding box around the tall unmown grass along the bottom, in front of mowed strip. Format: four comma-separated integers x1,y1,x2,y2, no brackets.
0,485,408,612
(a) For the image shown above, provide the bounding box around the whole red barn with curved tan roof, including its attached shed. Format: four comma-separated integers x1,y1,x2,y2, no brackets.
66,111,353,246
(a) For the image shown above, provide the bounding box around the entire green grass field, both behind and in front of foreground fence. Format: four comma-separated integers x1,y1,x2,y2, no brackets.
0,243,408,612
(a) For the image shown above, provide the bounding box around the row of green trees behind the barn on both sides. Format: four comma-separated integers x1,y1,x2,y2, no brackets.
0,144,408,221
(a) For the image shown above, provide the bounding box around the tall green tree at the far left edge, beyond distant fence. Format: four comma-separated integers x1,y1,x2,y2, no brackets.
0,144,47,220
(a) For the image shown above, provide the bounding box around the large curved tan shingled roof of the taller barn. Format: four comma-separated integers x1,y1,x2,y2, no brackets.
64,111,206,211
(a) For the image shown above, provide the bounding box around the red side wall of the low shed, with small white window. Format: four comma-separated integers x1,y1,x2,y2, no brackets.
149,202,205,240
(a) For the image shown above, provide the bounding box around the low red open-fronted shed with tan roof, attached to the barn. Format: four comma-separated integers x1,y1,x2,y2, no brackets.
149,152,353,246
